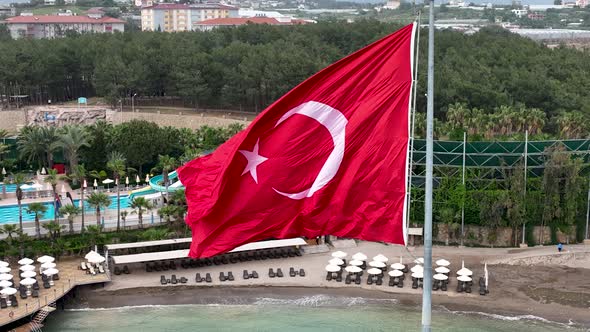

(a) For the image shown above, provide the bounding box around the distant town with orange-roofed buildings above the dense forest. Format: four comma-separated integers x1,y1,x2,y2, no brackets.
0,0,590,45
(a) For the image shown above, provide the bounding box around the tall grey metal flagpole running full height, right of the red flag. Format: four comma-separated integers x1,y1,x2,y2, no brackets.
422,0,434,332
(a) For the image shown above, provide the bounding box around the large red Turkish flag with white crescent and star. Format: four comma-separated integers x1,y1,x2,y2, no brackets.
178,24,415,258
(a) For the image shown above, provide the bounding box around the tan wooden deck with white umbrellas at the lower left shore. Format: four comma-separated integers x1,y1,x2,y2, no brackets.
0,258,111,330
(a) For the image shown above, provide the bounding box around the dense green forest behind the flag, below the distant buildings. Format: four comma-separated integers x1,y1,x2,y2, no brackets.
0,21,590,139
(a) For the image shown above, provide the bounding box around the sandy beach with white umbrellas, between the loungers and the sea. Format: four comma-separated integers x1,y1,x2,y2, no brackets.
67,242,590,328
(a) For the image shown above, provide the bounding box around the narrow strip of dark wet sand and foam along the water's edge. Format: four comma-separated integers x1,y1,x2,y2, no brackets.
74,285,590,328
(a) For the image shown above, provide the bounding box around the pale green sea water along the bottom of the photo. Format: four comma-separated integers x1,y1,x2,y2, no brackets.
43,295,584,332
